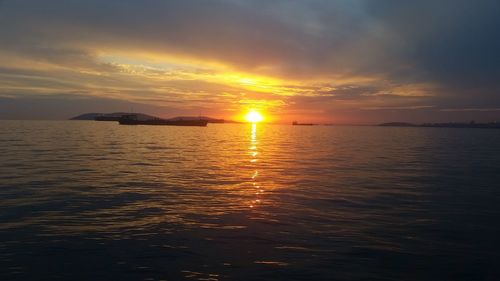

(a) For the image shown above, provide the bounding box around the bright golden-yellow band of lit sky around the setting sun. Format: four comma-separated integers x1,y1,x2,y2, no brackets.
0,46,414,123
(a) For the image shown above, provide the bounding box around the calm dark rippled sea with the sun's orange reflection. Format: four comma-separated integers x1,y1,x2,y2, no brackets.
0,121,500,280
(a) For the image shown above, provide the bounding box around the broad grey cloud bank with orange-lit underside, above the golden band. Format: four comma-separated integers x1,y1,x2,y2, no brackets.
0,0,406,78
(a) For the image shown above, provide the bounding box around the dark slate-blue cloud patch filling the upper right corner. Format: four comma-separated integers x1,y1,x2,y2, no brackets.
369,0,500,92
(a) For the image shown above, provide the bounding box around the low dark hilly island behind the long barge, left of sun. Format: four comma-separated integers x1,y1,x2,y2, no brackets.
70,112,230,123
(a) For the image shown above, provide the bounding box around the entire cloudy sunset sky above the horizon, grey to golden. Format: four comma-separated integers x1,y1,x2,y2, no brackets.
0,0,500,124
